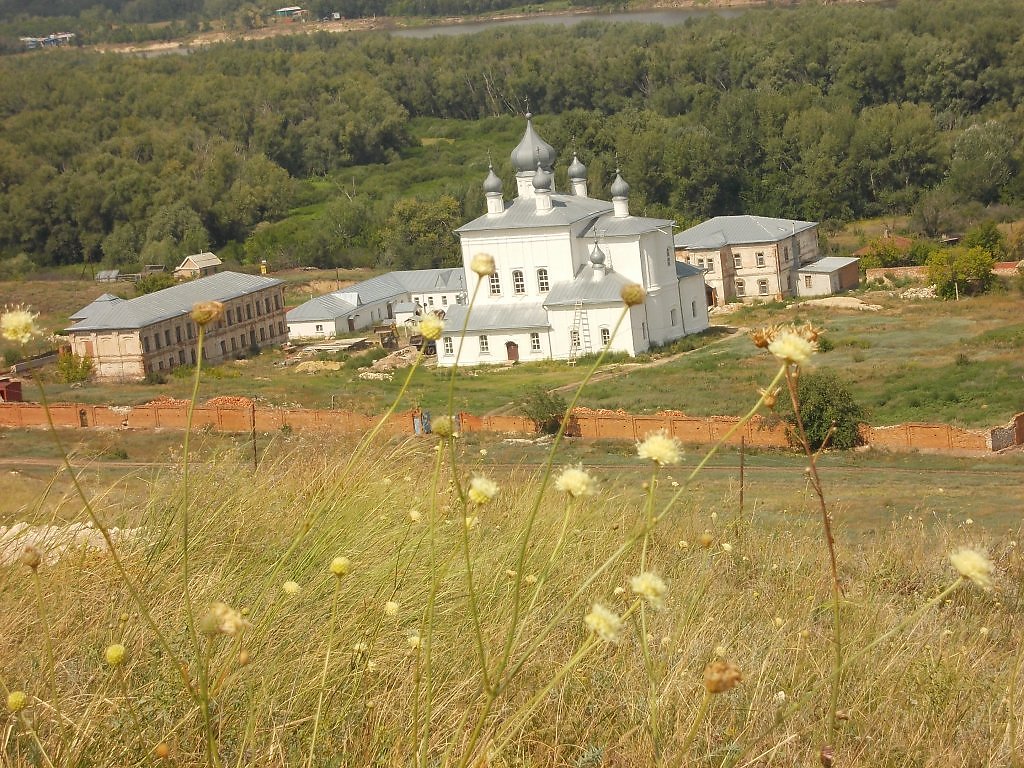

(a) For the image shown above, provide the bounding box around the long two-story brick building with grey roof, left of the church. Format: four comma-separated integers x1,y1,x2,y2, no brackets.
65,272,288,381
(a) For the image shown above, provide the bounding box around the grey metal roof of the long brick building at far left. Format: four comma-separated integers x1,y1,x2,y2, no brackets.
66,272,281,333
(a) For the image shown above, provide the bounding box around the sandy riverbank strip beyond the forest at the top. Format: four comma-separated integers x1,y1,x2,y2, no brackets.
92,0,883,54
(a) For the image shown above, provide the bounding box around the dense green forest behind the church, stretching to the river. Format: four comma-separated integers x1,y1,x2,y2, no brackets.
0,0,1024,273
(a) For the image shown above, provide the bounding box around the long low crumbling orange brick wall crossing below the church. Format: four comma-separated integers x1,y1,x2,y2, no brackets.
0,402,1024,452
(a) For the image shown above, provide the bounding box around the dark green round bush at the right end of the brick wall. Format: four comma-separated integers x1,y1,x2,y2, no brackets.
779,369,867,451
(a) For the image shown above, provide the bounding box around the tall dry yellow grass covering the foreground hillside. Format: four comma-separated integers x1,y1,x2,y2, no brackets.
0,428,1024,767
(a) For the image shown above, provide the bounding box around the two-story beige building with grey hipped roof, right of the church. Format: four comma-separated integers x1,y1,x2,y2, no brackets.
675,216,819,306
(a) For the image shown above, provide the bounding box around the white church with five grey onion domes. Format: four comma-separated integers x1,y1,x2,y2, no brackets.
437,114,709,367
